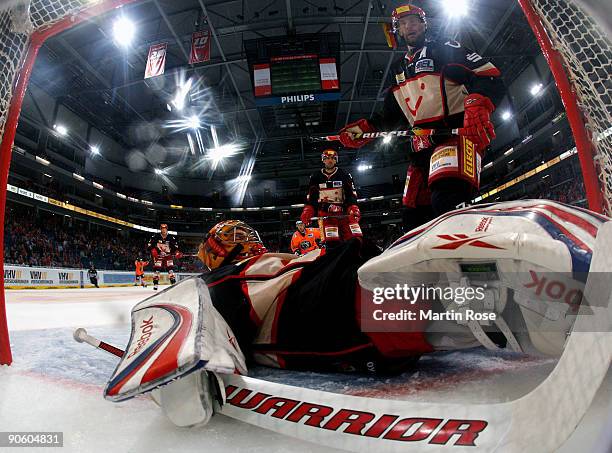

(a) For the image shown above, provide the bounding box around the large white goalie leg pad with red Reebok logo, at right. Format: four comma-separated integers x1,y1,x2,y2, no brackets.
359,200,609,356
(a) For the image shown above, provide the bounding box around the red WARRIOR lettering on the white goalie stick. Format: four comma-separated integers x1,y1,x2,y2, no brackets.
225,385,488,447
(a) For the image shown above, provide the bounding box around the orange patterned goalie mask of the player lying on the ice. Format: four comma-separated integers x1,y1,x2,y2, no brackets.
198,220,267,270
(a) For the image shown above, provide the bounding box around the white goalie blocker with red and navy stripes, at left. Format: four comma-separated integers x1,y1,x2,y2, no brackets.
104,277,247,401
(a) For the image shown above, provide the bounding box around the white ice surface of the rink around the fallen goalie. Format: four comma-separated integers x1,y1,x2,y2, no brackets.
0,287,612,453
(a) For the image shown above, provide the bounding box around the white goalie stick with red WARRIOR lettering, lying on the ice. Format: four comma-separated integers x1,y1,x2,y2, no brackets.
75,222,612,452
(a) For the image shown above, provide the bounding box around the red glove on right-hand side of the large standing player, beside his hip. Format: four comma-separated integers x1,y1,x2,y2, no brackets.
459,93,495,148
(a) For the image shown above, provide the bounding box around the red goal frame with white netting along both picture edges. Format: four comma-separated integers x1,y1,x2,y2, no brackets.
0,0,612,364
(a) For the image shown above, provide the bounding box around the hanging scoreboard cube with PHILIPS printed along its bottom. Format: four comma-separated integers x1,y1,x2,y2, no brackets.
244,33,341,107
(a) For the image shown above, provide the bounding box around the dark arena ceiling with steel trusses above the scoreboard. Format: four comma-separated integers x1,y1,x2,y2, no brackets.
21,0,550,185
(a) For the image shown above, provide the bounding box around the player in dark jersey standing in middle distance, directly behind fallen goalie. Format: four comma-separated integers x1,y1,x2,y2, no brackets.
301,149,363,246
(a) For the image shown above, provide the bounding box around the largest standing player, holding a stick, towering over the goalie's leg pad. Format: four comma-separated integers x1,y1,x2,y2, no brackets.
340,5,501,227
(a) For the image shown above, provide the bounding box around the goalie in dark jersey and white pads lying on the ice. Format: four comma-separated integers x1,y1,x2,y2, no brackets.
105,200,608,426
